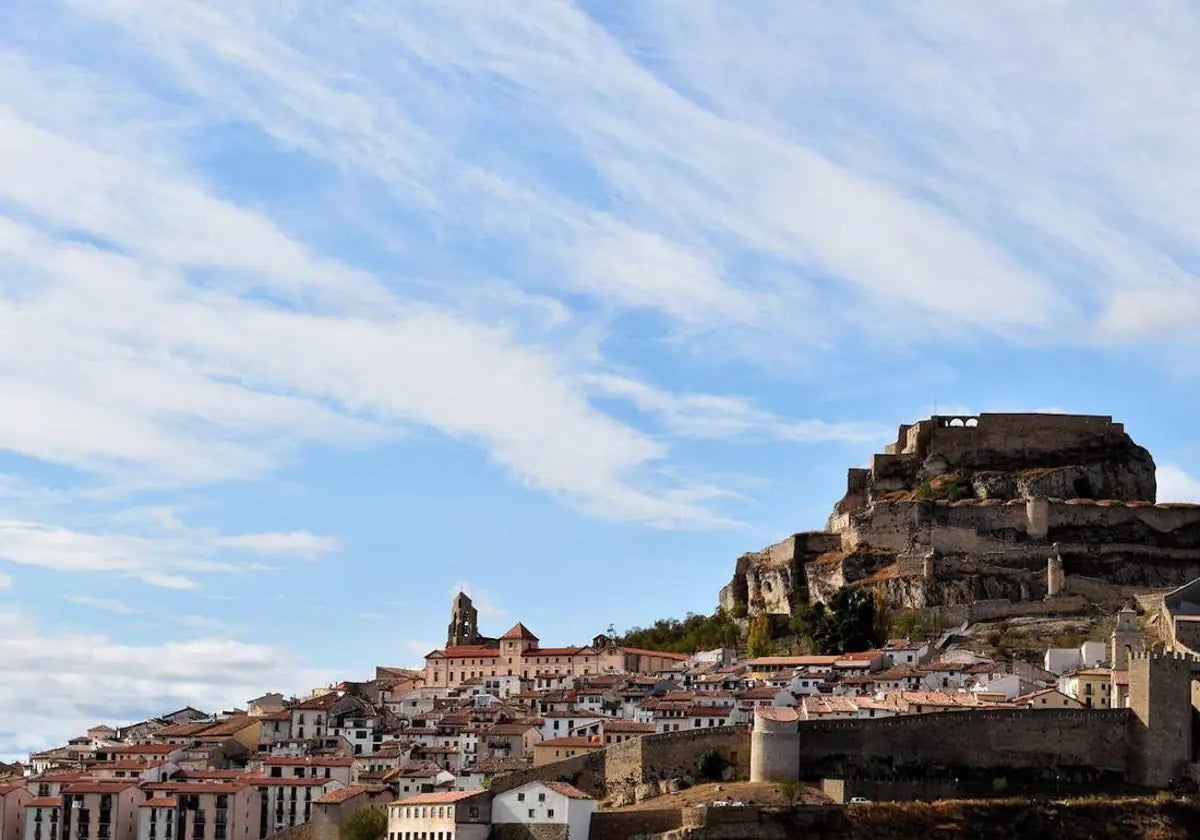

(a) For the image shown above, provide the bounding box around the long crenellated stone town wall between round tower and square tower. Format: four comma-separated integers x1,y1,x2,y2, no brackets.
750,653,1200,787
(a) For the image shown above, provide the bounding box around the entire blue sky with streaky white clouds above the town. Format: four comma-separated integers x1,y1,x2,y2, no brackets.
0,0,1200,756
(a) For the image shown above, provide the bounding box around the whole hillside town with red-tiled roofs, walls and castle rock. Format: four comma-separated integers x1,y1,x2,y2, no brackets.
7,415,1200,840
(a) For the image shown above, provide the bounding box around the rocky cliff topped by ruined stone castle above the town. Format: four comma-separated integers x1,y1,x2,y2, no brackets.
721,414,1200,614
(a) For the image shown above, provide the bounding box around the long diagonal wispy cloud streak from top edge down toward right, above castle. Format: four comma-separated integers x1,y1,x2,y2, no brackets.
56,2,1068,341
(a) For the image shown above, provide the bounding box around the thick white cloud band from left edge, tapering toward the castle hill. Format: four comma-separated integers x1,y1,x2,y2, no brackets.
0,118,729,523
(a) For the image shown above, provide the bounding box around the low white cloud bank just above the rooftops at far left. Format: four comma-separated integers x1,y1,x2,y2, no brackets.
0,611,334,758
